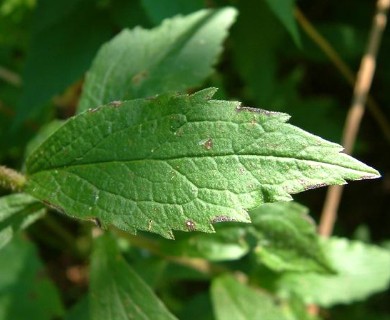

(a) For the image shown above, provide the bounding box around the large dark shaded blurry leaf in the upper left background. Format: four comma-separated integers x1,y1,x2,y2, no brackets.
18,0,113,123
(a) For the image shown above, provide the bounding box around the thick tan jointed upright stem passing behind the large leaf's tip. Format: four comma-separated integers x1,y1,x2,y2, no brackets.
319,0,390,237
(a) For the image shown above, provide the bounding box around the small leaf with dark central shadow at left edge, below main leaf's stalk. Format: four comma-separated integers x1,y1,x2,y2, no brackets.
0,193,46,249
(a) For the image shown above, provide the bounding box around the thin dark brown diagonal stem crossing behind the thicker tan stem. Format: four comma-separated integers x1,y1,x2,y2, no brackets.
294,7,390,142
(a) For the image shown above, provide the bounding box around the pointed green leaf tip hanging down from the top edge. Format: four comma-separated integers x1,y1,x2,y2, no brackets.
265,0,302,47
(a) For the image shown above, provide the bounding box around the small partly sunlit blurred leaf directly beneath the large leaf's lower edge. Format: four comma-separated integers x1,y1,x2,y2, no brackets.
161,225,249,261
